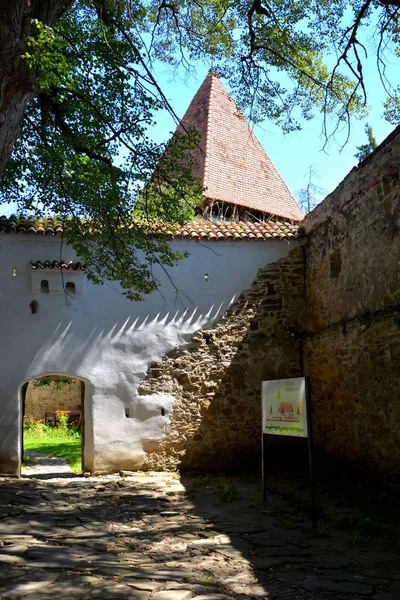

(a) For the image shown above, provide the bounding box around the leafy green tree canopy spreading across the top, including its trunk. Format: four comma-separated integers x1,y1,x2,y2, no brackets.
0,0,400,299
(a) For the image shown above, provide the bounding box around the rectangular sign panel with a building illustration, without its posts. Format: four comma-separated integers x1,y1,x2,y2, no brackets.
262,377,308,437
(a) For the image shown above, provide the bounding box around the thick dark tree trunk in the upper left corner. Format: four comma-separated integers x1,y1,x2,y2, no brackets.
0,0,71,178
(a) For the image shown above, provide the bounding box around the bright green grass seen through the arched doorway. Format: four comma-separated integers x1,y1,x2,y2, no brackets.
24,419,82,473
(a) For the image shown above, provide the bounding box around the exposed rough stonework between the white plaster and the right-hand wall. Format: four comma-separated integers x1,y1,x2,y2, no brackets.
139,247,305,471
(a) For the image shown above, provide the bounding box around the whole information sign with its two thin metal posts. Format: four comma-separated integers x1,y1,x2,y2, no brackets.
261,377,317,528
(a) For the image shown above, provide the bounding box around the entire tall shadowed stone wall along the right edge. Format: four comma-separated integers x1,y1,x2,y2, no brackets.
302,129,400,474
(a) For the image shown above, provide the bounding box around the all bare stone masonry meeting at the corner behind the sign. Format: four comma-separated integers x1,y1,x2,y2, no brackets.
139,129,400,479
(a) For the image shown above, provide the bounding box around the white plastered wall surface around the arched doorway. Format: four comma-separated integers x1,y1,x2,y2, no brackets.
0,233,297,474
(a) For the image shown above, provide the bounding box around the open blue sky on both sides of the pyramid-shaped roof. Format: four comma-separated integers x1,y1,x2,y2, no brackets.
148,54,397,209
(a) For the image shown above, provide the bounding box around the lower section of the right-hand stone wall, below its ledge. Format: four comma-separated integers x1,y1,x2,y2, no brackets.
305,310,400,474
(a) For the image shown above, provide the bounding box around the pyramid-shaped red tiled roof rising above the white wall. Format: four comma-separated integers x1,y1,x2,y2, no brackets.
182,73,304,221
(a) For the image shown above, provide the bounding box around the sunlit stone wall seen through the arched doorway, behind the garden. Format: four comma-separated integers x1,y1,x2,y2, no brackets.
25,380,82,420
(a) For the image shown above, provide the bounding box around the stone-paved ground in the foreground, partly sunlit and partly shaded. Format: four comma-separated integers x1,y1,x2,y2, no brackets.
0,454,400,600
